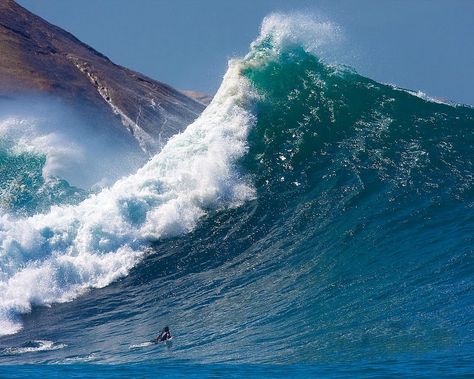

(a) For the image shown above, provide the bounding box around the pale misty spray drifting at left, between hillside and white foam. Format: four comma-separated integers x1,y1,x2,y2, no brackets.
0,99,149,191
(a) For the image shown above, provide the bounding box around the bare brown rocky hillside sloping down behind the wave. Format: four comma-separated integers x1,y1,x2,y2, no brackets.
0,0,204,154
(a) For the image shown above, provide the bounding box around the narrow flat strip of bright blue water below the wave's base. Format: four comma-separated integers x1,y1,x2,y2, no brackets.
0,359,472,379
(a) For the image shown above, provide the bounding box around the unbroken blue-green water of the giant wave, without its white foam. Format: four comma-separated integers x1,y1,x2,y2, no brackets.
0,14,474,377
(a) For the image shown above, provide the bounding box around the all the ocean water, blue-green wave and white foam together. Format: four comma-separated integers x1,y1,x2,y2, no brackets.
0,15,474,377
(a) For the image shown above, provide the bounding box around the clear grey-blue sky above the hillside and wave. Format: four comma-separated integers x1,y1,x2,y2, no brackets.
17,0,474,105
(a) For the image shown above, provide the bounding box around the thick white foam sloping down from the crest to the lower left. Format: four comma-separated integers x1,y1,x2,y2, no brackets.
0,61,254,334
